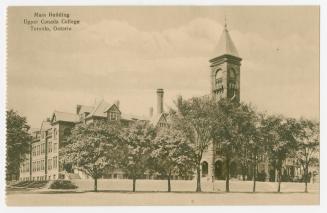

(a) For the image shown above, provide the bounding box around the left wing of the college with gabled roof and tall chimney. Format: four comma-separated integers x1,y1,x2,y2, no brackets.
20,89,167,181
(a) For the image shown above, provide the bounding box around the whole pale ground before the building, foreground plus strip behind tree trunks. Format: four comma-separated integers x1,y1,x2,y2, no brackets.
6,180,319,206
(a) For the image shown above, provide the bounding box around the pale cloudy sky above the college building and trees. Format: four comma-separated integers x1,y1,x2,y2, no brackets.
7,6,319,128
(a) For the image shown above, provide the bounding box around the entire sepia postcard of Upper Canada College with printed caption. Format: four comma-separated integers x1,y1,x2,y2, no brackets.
3,5,320,206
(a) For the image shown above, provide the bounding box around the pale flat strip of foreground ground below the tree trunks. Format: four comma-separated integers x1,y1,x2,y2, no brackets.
6,192,319,206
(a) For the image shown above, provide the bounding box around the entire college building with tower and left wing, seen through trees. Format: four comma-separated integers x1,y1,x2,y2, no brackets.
20,25,301,181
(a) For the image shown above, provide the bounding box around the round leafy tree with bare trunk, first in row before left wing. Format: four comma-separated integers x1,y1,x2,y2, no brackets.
60,121,120,191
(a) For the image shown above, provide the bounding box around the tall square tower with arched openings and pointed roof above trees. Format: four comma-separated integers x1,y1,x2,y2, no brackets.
209,24,242,101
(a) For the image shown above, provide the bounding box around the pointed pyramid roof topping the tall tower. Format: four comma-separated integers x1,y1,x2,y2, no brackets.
214,23,239,57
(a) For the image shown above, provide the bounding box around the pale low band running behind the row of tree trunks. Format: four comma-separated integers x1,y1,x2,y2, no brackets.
72,179,319,192
